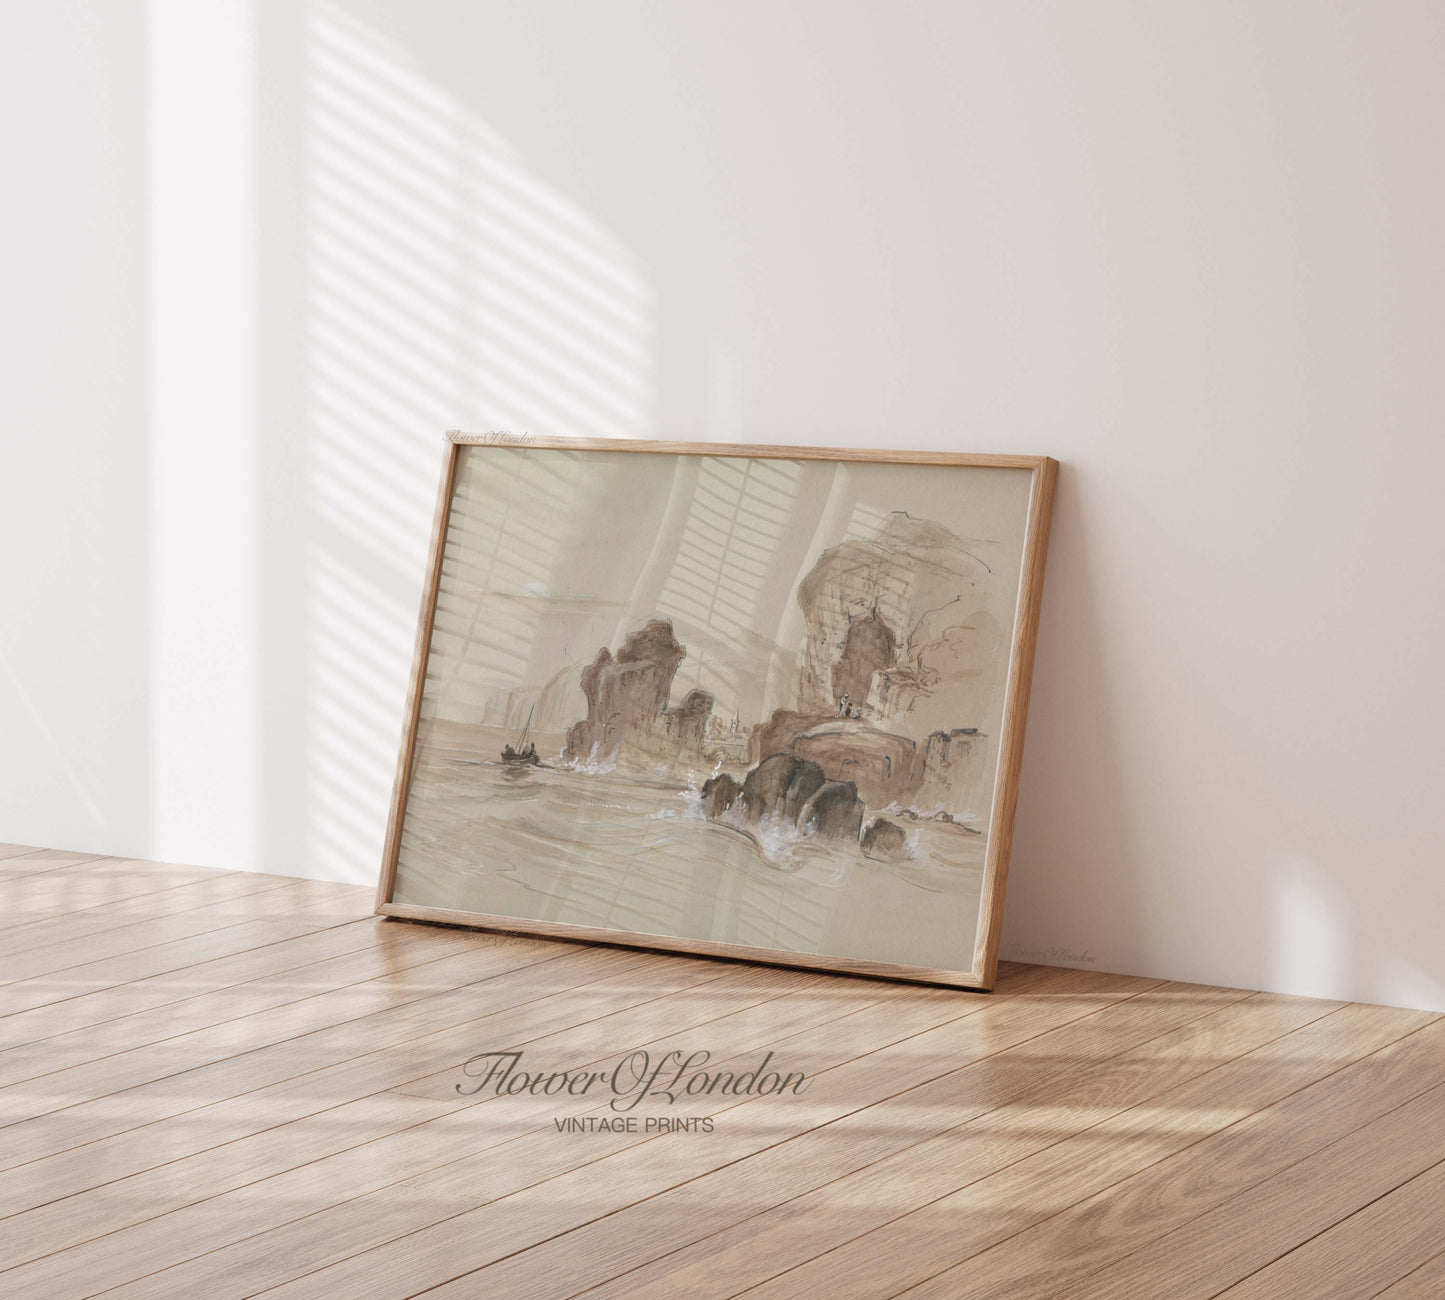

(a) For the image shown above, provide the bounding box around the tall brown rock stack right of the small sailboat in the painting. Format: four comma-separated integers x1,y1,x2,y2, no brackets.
564,618,712,763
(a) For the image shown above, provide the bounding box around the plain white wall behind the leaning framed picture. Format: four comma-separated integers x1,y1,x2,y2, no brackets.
0,0,1445,1010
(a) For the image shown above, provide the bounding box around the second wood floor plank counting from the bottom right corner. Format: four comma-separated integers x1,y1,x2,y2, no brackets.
1220,1155,1445,1300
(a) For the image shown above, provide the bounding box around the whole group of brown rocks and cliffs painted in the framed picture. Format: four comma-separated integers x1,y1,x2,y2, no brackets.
487,511,1007,861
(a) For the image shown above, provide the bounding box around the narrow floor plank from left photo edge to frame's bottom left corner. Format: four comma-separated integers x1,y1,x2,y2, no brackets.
0,880,371,1015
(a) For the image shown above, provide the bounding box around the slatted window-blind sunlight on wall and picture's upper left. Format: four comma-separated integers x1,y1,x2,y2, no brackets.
298,3,655,880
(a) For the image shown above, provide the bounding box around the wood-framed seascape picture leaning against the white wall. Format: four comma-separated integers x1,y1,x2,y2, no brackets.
377,433,1058,988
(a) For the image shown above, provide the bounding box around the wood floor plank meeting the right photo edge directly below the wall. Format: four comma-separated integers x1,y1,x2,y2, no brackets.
900,1008,1445,1300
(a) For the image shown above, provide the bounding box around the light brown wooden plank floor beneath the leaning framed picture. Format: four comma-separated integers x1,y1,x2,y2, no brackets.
0,845,1445,1300
